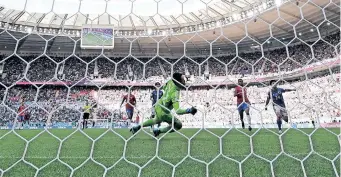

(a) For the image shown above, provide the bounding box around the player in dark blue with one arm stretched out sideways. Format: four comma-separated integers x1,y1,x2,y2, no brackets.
265,80,296,133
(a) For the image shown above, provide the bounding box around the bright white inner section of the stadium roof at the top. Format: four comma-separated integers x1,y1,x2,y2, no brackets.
0,0,274,29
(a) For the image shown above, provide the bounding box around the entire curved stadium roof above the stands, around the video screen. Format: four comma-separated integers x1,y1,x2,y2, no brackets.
0,0,340,57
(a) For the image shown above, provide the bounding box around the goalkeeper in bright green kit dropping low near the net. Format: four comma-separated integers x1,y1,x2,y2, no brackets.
130,73,197,137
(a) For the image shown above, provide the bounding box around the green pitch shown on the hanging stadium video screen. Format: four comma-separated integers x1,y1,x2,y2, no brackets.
82,33,113,46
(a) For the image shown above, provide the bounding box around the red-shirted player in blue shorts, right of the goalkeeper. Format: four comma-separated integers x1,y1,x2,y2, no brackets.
234,79,252,131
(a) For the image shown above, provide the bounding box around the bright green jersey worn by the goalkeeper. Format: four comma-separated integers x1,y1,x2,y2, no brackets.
157,80,187,115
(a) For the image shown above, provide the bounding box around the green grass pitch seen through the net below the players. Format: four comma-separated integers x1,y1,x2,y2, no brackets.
0,128,340,177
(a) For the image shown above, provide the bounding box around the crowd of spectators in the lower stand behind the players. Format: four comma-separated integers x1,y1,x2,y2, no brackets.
0,75,340,127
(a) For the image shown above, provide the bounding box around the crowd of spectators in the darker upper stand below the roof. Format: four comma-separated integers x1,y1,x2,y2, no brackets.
0,33,340,85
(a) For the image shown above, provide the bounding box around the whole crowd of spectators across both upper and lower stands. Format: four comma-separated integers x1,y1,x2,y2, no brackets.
0,33,340,127
